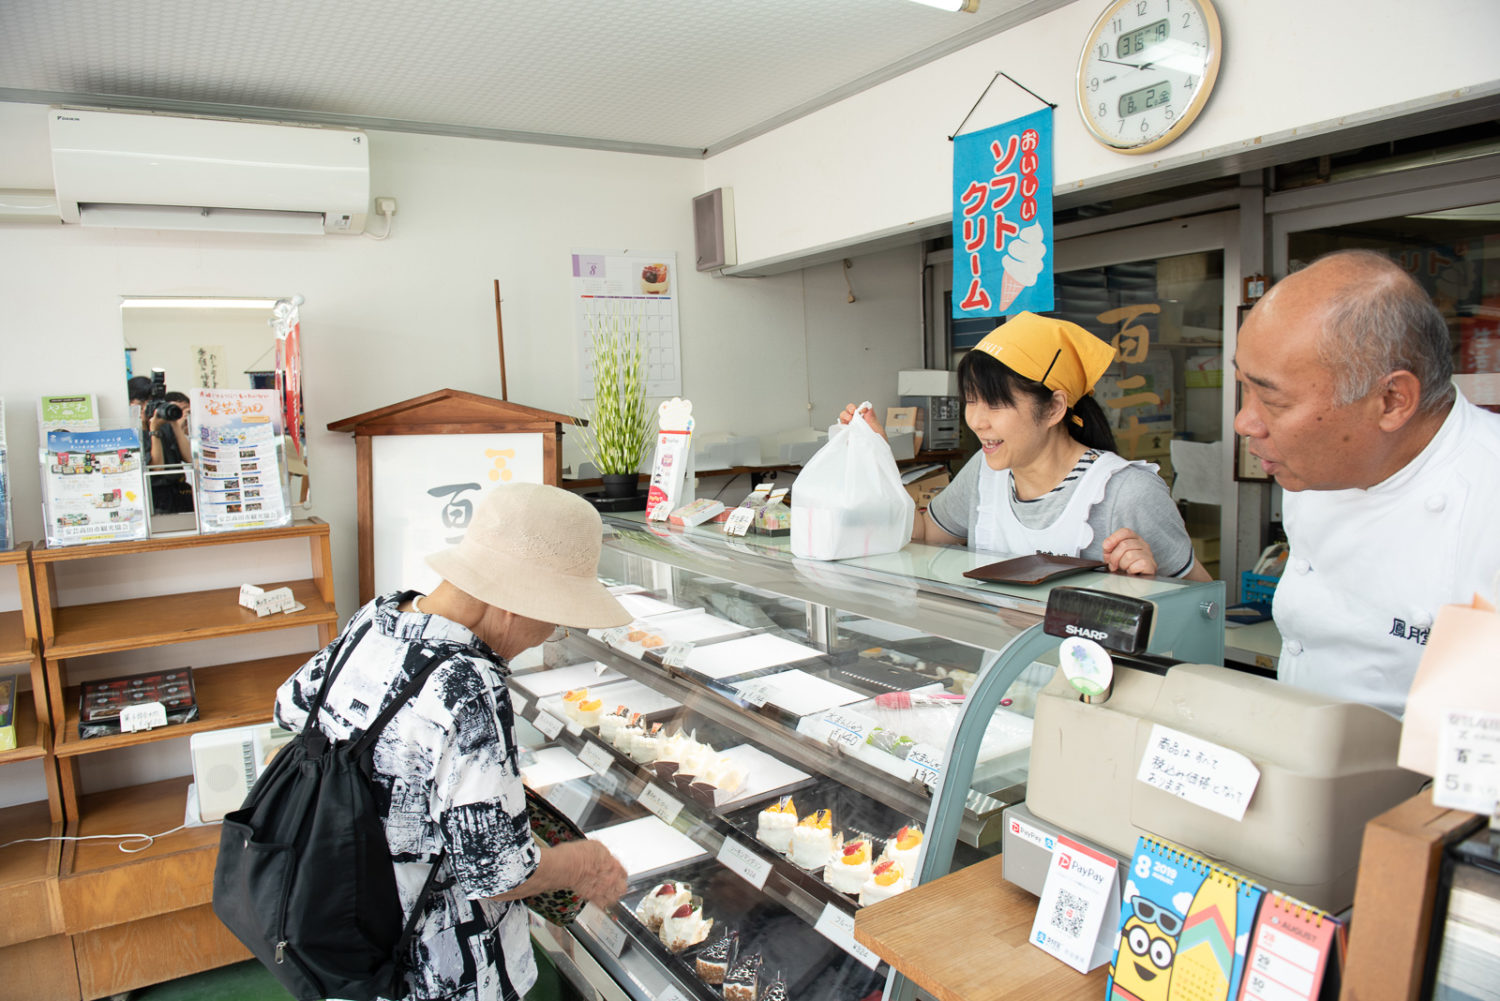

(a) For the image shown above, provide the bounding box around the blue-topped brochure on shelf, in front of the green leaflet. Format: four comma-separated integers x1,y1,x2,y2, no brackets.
41,428,146,546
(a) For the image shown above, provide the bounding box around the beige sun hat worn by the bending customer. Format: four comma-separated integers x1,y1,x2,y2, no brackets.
428,483,632,629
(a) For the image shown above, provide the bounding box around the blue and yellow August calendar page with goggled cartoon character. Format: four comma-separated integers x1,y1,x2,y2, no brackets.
1109,837,1263,1001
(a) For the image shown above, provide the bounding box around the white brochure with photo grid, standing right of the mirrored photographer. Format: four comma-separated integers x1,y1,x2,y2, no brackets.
189,389,291,531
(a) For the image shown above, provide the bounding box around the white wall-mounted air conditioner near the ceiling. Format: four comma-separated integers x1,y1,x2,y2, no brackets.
50,108,371,234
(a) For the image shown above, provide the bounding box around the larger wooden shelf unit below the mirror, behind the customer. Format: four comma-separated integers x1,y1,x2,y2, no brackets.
29,521,338,999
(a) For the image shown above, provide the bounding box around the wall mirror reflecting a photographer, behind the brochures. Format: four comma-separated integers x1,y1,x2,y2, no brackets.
120,296,311,533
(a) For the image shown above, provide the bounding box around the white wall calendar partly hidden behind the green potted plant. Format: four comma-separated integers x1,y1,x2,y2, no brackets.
573,251,683,399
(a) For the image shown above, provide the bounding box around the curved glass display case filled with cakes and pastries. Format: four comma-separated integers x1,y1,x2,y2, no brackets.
510,515,1224,1001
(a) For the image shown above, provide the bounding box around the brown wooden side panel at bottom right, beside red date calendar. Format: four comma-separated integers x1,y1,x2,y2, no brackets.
1338,791,1485,1001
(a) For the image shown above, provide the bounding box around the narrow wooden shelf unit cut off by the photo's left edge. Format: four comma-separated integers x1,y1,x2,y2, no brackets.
0,546,78,1001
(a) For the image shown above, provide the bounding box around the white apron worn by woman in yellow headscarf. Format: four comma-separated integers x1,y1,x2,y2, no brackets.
971,452,1145,557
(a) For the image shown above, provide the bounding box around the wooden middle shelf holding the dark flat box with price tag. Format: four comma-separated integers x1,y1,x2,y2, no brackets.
57,653,312,758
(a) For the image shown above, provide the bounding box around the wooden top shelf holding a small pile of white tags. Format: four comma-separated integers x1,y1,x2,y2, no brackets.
44,582,339,660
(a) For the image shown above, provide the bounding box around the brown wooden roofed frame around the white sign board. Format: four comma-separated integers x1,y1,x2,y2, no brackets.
329,387,585,605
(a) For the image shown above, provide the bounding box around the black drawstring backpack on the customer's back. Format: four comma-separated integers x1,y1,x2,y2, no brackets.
213,641,452,1001
